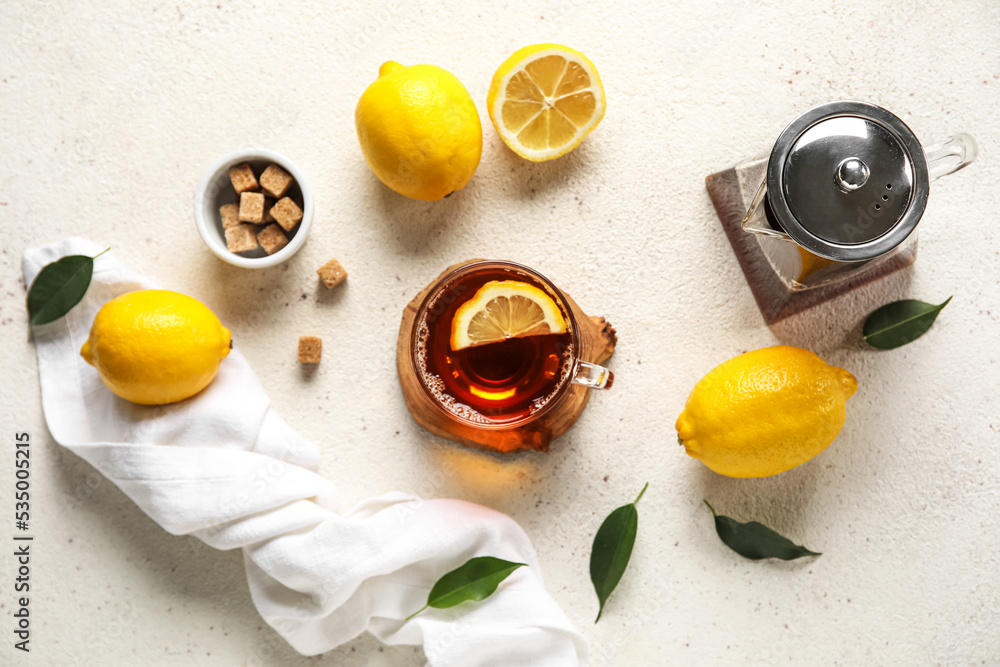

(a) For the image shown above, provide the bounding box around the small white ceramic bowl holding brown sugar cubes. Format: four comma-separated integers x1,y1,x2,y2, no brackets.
194,148,313,269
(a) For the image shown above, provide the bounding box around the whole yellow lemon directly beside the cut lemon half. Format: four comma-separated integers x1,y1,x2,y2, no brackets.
354,61,483,201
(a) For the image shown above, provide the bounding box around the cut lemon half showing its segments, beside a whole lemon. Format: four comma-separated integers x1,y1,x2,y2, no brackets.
486,44,605,162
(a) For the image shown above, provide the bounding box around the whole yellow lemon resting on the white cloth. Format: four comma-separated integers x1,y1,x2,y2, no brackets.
80,290,232,405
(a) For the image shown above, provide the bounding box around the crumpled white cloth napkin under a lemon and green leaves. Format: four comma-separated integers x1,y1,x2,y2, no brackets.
24,238,587,667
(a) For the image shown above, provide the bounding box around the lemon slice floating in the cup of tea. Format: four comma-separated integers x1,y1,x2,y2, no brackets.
451,280,566,350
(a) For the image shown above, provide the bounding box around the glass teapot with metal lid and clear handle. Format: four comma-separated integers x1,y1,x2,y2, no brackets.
742,101,978,292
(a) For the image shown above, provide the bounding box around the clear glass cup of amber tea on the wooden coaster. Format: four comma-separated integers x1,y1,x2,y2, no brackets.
400,261,614,451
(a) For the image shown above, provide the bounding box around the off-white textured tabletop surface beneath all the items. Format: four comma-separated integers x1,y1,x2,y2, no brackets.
0,0,1000,667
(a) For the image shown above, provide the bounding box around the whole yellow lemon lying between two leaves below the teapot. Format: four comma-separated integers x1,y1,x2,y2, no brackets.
676,345,858,477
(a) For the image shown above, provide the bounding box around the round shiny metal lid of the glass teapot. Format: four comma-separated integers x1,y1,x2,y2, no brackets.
767,101,928,262
